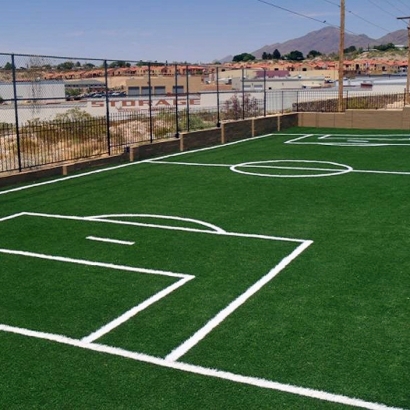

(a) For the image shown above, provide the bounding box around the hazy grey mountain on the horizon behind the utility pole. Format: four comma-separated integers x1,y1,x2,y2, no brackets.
218,27,407,63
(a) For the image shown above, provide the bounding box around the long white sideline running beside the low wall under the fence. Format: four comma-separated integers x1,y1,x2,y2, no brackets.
0,133,276,195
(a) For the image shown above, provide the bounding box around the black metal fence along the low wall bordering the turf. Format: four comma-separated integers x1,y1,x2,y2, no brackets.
0,53,404,174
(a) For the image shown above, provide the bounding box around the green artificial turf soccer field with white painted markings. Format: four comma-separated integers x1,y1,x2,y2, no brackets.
0,128,410,409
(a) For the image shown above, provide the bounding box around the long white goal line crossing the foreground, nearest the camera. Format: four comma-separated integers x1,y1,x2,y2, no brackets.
0,324,405,410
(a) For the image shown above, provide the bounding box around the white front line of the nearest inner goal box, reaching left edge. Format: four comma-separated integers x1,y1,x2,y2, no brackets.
0,249,194,278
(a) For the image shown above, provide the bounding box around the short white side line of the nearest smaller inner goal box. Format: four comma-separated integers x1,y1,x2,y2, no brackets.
82,276,193,343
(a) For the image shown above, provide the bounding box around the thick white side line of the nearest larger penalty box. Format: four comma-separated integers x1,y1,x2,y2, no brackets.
165,241,313,361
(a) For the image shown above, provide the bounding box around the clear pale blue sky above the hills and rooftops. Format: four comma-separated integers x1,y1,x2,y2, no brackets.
0,0,410,63
